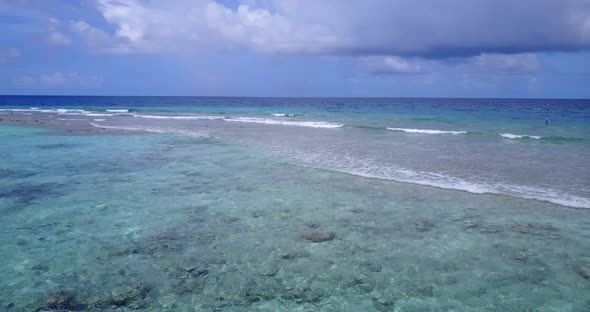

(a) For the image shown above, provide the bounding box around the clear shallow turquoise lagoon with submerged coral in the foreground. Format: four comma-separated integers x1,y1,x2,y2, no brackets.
0,126,590,311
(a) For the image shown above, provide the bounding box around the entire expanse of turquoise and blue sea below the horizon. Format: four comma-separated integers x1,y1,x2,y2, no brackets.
0,96,590,311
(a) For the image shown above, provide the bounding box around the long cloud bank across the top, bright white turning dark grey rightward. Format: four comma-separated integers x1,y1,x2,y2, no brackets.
72,0,590,58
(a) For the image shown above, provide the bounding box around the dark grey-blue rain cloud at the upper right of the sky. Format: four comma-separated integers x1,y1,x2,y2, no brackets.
279,0,590,58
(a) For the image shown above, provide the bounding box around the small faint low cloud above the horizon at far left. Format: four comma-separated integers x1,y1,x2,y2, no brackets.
12,71,103,88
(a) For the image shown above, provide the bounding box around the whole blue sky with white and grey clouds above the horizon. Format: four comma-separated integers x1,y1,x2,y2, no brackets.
0,0,590,98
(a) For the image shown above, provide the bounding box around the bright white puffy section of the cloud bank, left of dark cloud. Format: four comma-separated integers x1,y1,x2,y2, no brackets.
71,0,340,54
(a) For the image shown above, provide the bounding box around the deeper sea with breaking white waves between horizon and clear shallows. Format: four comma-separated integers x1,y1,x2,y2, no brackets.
0,96,590,208
